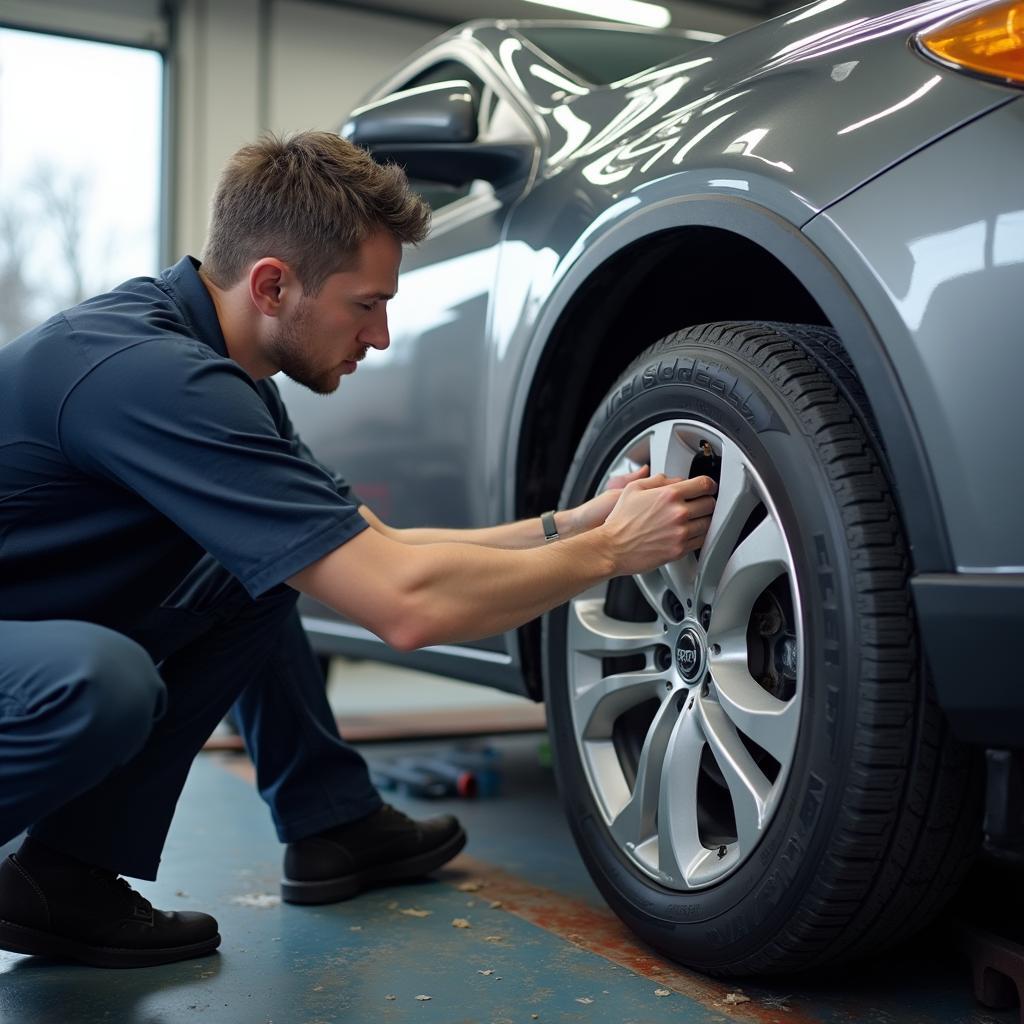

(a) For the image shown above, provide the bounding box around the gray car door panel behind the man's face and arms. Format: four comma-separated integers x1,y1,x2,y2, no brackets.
279,59,536,650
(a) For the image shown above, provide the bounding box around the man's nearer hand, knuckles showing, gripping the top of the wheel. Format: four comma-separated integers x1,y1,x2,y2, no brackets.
599,473,718,575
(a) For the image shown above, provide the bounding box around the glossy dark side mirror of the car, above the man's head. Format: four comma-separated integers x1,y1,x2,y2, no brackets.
341,80,534,186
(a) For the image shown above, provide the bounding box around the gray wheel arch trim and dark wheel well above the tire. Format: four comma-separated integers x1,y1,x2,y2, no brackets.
509,199,952,697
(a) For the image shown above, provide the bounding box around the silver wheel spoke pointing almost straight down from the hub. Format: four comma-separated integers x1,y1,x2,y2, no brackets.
657,710,705,888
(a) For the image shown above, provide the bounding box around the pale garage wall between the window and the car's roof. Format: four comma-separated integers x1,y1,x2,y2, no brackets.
168,0,439,258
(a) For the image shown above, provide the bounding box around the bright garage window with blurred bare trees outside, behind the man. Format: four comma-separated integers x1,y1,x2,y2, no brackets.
0,29,164,344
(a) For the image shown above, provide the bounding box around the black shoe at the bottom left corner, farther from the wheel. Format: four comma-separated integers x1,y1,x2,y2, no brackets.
0,837,220,967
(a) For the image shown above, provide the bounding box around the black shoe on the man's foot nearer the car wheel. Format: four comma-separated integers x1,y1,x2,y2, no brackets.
281,804,466,903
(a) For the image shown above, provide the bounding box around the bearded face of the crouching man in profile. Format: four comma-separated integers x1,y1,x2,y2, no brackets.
267,231,401,394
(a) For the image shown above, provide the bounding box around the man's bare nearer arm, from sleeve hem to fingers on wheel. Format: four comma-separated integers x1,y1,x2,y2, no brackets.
288,476,715,650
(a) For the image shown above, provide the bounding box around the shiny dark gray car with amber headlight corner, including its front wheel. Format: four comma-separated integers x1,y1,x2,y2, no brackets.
284,0,1024,975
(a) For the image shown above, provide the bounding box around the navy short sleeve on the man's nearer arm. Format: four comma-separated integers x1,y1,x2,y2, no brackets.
58,340,367,597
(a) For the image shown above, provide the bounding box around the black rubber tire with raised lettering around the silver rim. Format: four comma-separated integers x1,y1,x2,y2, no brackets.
543,323,982,976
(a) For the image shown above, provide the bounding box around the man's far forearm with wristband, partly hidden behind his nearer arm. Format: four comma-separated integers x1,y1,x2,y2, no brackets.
359,466,647,549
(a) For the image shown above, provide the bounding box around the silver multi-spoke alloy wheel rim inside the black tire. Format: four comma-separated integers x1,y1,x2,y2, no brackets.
567,419,804,890
